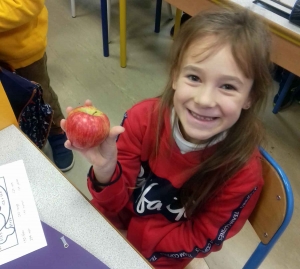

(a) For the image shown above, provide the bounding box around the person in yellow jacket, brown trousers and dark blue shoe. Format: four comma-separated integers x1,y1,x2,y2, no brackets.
0,0,74,171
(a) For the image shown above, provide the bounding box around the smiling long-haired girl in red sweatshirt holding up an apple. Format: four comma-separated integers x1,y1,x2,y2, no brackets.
62,7,271,268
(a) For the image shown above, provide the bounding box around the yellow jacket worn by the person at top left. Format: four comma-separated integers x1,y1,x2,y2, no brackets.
0,0,48,69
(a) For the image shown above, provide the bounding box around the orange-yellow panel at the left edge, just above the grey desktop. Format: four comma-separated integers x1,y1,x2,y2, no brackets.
0,81,18,130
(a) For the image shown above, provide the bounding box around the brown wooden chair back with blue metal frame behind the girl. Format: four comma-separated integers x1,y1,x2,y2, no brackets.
243,148,294,269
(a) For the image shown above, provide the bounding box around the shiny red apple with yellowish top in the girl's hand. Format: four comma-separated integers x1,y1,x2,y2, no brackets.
65,106,110,149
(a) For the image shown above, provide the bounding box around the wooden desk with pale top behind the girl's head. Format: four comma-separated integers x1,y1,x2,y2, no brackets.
165,0,300,76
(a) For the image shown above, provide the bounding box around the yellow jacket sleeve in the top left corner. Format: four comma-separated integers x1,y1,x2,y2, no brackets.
0,0,45,32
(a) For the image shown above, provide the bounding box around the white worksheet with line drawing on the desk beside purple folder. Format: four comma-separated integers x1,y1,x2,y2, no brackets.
0,161,47,265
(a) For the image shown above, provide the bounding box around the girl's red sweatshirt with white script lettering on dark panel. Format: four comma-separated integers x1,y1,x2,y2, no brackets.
88,99,263,269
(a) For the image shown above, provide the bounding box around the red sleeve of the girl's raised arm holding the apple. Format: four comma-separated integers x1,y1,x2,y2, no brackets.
88,108,143,214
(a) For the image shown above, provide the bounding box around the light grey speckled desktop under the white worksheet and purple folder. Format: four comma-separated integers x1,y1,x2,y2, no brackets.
0,125,151,269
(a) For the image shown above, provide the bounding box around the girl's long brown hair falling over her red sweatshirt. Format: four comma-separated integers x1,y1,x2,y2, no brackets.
156,8,272,217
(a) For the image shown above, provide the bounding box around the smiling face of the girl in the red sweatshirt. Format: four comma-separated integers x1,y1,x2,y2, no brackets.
173,37,253,144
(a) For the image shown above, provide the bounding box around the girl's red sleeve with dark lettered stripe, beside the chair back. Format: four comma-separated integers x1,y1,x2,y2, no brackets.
128,158,263,266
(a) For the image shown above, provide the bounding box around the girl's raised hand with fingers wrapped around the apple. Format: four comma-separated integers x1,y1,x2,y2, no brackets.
60,100,125,183
